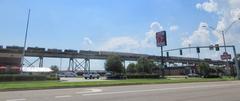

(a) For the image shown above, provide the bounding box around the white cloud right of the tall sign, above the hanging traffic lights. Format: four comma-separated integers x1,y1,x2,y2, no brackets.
182,22,211,47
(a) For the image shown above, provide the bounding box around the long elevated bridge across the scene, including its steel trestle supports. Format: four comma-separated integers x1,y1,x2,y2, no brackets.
0,46,225,71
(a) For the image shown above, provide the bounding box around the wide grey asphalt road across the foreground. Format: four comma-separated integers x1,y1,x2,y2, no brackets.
0,81,240,101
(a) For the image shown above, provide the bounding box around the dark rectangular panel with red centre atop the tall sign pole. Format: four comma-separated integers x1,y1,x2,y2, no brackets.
156,31,167,47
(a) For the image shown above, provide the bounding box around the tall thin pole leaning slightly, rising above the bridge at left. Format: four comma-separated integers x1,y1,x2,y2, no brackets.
21,9,31,70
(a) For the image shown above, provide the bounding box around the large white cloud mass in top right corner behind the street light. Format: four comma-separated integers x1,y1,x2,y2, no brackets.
206,0,240,45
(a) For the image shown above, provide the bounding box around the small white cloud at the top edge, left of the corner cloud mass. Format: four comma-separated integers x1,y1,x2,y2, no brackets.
196,0,218,13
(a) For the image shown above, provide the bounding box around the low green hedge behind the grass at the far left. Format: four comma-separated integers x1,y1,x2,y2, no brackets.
0,74,58,82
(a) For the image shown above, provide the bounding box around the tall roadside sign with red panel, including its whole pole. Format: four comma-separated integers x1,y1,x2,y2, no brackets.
156,31,167,77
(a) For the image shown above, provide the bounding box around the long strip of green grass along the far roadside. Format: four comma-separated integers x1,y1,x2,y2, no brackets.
0,77,234,91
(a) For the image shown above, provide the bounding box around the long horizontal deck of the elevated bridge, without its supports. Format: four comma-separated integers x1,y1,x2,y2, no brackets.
0,48,225,65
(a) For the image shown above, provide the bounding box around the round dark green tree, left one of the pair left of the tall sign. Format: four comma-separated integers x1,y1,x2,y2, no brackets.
105,55,124,74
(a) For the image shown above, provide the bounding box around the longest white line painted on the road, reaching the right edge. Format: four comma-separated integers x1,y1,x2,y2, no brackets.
82,84,239,96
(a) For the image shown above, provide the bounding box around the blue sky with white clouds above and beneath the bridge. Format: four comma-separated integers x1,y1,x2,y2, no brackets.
0,0,240,69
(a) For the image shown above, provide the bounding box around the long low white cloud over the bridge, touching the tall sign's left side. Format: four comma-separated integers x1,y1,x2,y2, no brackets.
101,22,163,53
